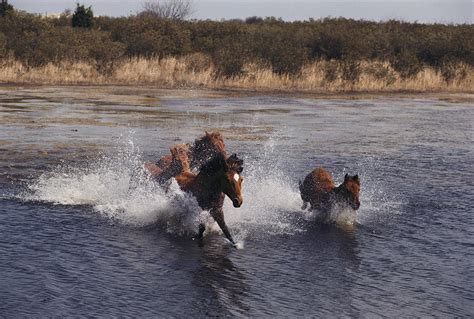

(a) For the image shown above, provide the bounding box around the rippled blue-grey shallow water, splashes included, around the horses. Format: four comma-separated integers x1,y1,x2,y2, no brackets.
0,87,474,317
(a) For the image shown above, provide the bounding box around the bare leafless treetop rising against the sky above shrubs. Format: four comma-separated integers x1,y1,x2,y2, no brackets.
141,0,193,20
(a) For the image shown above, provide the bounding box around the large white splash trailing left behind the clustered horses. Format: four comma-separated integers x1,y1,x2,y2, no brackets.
22,140,199,233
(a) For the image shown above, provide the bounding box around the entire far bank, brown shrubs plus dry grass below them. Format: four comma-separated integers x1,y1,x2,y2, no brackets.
0,7,474,92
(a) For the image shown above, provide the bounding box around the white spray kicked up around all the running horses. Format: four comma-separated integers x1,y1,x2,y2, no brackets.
22,138,404,240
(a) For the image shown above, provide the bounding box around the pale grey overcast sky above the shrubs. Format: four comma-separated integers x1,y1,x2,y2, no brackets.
9,0,473,24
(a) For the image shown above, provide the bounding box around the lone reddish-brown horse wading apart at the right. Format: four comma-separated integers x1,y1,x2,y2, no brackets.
300,168,360,211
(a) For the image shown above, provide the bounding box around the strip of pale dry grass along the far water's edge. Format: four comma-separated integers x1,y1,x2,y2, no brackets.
0,55,474,93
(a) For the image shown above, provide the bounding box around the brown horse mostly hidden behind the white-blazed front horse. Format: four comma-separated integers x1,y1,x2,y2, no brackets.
144,132,227,183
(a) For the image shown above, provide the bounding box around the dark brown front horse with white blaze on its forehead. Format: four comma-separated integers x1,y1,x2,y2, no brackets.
173,151,243,246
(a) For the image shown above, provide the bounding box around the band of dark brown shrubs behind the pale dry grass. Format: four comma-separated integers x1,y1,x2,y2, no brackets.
0,2,474,81
